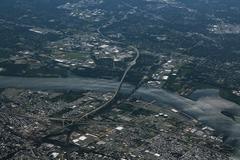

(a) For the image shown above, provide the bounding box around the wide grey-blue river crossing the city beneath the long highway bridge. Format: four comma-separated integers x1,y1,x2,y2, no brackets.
0,76,240,146
